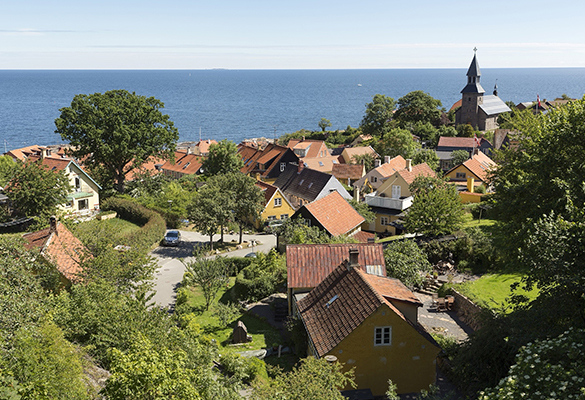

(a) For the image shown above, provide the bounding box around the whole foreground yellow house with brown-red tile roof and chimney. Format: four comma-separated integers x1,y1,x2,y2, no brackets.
297,248,440,396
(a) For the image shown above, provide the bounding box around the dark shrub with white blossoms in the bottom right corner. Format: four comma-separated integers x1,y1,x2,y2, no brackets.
479,329,585,400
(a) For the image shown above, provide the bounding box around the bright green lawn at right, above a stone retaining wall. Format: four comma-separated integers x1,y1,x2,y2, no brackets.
454,274,538,313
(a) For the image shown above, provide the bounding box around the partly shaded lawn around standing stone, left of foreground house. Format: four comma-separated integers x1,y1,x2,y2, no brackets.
181,277,283,351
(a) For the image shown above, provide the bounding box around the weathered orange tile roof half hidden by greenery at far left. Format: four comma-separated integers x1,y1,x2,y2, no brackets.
23,222,88,282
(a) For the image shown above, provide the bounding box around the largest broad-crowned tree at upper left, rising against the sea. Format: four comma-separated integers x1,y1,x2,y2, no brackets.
55,90,179,193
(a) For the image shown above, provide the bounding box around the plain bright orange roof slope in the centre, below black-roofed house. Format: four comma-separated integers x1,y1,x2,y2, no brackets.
303,191,365,236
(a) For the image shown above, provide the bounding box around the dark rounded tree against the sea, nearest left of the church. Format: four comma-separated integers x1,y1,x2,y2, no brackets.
394,90,442,126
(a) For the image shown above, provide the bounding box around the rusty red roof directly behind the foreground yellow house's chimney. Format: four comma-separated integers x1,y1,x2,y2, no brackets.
286,243,386,288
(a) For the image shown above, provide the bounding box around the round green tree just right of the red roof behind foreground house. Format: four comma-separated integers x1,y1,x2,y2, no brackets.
384,240,432,288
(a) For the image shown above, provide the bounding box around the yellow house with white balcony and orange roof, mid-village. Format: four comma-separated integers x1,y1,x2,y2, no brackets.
362,160,435,235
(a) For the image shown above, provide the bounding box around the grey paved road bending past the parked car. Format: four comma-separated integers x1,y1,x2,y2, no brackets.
150,231,276,308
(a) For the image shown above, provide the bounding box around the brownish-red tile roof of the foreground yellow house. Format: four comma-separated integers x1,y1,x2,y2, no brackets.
297,263,422,357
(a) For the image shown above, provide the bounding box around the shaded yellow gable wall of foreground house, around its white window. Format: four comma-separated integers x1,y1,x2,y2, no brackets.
328,305,439,396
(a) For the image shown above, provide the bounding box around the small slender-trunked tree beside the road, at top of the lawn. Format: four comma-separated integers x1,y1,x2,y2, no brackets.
182,256,230,310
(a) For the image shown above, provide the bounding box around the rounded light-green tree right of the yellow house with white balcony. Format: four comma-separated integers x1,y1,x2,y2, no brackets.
405,176,463,236
